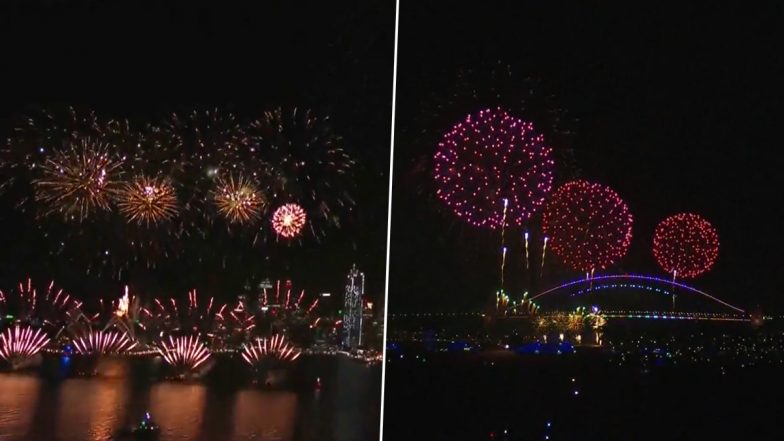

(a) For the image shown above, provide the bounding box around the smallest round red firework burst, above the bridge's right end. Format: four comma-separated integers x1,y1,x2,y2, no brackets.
653,213,719,279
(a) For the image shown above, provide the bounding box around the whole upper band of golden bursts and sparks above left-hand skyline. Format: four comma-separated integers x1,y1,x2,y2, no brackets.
0,108,354,280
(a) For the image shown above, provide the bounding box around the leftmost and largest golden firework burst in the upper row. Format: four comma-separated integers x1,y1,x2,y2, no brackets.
33,138,123,221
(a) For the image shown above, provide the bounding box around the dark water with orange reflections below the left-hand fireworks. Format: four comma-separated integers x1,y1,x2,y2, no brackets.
0,356,381,441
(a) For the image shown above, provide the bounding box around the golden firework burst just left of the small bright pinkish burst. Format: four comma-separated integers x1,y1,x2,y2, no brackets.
215,175,267,224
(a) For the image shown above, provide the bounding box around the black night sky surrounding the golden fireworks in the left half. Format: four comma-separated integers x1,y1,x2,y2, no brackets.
0,0,394,298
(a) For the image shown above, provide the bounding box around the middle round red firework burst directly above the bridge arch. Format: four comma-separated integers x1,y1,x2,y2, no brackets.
542,181,632,272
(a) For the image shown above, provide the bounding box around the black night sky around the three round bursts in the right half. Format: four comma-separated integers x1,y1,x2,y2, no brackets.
389,1,784,312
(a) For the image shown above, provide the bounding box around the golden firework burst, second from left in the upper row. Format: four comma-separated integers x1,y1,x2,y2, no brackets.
117,176,178,226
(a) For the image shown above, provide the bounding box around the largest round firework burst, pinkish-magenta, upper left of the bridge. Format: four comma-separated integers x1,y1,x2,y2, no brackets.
434,109,555,228
